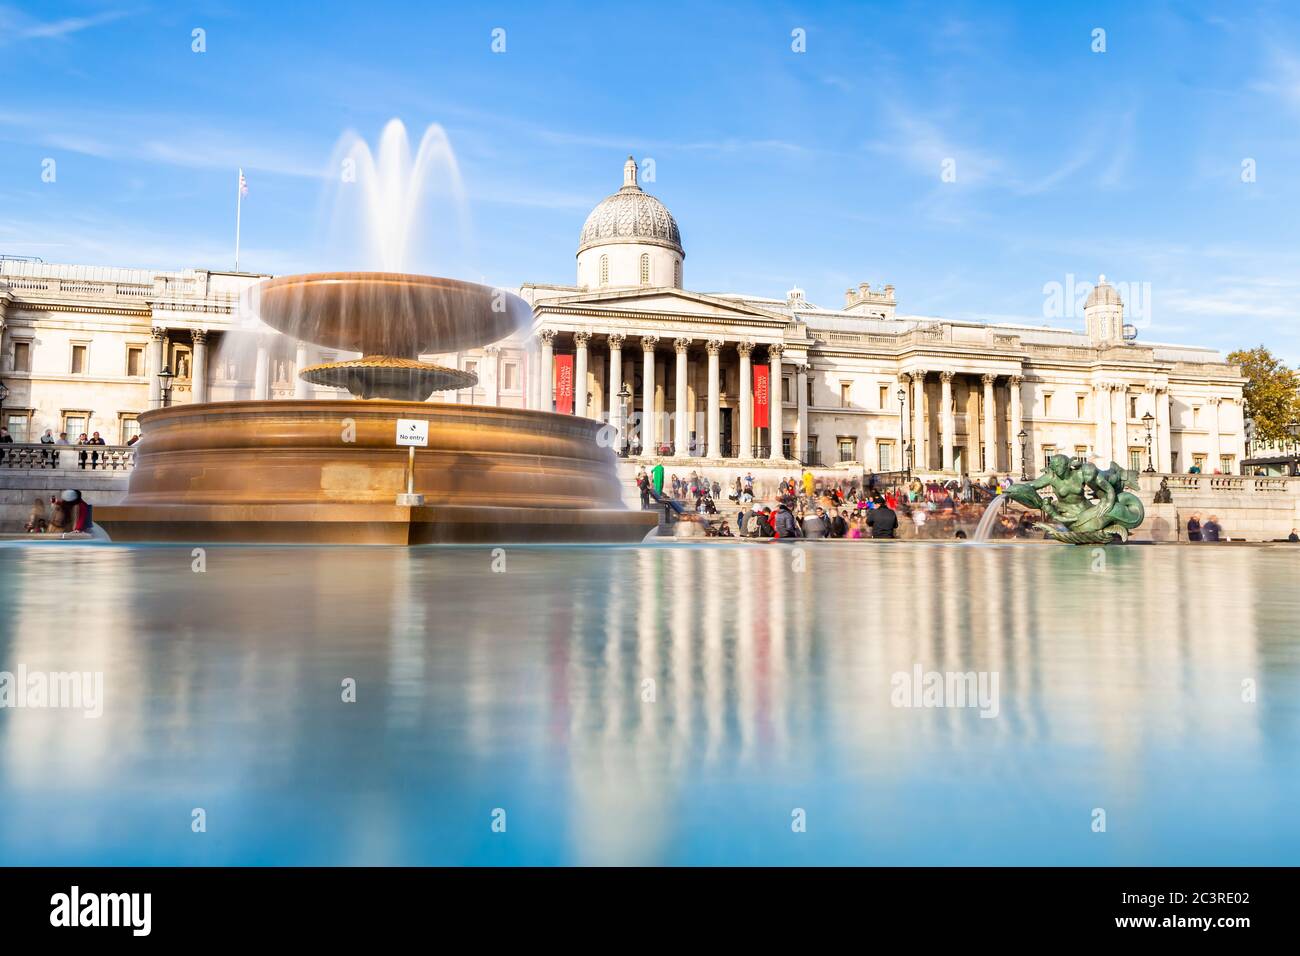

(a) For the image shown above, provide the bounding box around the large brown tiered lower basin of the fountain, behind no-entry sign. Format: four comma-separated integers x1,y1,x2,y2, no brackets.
95,399,657,545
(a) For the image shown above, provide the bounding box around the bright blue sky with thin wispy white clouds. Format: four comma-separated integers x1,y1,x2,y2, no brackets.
0,0,1300,363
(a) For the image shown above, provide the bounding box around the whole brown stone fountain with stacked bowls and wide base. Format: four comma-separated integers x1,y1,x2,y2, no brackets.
95,120,657,545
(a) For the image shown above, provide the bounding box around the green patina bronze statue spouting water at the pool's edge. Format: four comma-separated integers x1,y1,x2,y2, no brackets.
1006,455,1147,545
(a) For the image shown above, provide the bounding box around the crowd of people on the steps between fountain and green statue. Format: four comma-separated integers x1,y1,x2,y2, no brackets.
637,462,1037,538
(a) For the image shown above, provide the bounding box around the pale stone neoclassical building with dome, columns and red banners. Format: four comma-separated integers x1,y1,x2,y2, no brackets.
0,157,1245,475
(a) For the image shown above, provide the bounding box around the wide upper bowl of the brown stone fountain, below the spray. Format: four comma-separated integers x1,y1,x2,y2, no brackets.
255,272,532,359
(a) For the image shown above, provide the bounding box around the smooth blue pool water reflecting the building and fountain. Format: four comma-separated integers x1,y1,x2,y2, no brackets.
0,542,1300,865
